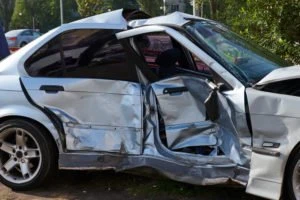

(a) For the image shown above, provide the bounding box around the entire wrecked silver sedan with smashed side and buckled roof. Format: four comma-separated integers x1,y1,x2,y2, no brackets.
0,10,300,200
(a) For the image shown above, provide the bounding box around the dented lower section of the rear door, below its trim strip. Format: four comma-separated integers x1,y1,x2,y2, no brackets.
66,125,142,154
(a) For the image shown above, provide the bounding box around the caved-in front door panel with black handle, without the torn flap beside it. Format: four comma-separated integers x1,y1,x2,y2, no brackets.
151,76,220,152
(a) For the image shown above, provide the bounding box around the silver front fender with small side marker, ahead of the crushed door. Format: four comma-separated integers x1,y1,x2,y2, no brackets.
246,88,300,199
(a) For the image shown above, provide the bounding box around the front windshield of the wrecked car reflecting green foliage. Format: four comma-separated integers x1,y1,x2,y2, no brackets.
185,20,290,84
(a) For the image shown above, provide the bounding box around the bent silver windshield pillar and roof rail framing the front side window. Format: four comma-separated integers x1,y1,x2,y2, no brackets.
116,25,252,144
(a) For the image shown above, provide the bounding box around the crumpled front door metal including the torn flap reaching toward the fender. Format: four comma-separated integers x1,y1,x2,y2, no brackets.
152,76,248,165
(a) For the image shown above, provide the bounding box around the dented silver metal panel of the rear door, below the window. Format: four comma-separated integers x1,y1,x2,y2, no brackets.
24,78,142,154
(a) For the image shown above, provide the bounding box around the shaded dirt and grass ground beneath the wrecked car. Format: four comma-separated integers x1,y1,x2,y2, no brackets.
0,171,262,200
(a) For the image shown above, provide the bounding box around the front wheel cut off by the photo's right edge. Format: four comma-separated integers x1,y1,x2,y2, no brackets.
284,147,300,200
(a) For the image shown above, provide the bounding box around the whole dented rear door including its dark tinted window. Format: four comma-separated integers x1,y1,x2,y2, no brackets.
21,29,142,154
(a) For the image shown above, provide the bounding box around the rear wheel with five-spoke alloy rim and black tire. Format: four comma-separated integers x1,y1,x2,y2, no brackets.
0,119,57,190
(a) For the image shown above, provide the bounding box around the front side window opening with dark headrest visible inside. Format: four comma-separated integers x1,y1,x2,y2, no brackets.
134,32,210,80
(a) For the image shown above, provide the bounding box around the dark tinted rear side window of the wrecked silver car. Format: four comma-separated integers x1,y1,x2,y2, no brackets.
25,29,138,82
